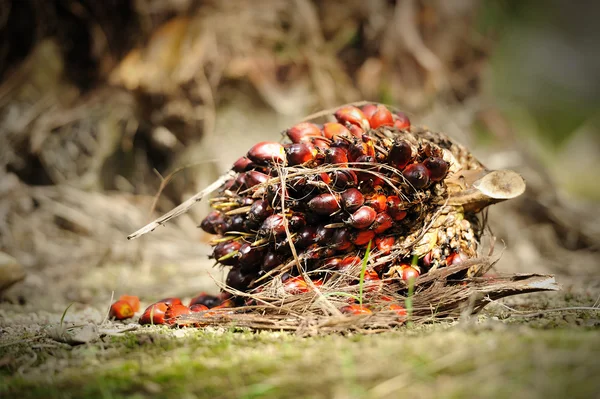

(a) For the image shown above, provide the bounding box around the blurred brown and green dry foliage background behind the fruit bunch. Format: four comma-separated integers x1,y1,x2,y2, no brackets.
0,0,600,302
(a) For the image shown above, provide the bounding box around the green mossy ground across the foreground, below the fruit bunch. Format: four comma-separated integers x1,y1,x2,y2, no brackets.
0,293,600,398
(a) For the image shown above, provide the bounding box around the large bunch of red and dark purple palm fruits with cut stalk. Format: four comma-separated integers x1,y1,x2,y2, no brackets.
200,104,514,303
